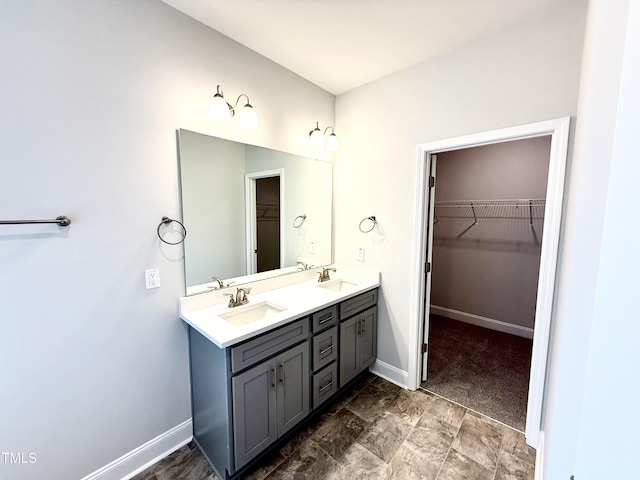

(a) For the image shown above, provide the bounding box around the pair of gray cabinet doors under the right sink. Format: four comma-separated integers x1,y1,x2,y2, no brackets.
340,306,378,388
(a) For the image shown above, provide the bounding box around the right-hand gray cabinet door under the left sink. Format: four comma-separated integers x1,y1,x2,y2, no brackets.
276,341,310,436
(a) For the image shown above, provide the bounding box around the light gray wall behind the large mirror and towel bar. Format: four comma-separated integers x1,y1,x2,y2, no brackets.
0,0,334,480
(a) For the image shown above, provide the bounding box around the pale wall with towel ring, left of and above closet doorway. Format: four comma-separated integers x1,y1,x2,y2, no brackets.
335,0,586,372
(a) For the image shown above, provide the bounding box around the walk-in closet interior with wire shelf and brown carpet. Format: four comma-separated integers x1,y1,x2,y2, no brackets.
421,136,551,431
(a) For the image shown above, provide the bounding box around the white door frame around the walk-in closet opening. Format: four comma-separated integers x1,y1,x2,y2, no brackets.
408,117,570,448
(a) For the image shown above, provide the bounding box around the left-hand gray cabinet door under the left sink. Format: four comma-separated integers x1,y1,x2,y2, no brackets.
232,359,278,470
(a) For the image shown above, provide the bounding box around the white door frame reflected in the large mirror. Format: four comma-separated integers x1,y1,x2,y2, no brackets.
244,168,285,275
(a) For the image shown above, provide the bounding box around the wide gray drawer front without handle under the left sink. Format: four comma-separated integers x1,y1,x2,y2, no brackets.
231,317,309,373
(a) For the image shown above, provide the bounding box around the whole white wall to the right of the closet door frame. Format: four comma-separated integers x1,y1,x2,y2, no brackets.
544,0,640,480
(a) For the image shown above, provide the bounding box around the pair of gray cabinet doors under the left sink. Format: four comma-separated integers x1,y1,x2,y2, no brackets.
232,342,309,469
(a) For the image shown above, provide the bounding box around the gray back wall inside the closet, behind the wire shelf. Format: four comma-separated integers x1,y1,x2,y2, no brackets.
431,137,551,328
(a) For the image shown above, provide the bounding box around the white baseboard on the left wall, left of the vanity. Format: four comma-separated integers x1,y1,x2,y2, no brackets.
82,419,193,480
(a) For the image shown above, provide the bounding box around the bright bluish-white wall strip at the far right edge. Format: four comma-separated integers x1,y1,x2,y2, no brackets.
576,1,640,480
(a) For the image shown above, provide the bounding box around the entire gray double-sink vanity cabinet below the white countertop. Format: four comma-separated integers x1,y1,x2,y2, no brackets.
189,289,378,480
